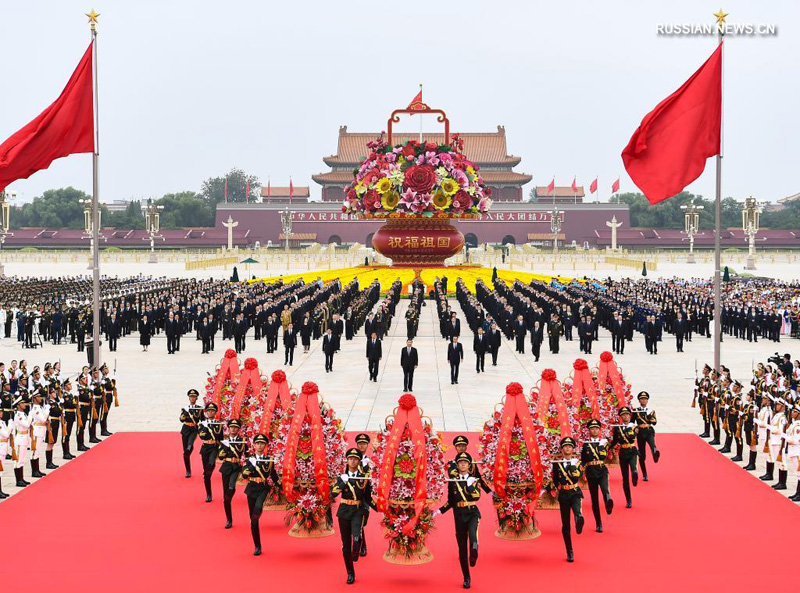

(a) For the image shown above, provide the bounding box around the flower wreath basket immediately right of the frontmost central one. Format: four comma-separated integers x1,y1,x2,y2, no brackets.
478,383,545,541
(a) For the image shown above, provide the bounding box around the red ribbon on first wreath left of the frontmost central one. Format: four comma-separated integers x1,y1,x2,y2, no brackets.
283,381,331,500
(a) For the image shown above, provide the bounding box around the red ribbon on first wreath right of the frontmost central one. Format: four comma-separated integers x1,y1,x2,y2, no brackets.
494,383,543,505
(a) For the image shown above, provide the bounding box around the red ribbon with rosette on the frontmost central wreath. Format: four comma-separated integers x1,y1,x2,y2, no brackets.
376,393,428,534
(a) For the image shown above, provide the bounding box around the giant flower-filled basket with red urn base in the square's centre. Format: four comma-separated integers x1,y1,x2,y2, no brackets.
342,118,492,268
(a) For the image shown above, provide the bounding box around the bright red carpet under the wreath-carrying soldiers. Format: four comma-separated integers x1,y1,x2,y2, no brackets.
0,433,800,593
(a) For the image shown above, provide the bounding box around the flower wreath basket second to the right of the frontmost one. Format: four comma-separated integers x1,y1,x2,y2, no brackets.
531,369,580,510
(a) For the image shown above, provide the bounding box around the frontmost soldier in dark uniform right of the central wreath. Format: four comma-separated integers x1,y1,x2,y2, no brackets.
434,451,481,589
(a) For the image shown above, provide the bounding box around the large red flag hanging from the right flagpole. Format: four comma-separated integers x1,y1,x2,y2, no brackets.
622,43,722,204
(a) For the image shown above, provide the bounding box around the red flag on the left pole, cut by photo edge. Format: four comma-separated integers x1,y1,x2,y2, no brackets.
0,43,94,191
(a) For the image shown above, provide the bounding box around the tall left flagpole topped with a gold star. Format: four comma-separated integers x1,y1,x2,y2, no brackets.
86,8,100,368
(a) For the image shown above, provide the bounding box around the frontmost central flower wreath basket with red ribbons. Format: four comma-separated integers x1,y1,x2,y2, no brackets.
372,393,445,565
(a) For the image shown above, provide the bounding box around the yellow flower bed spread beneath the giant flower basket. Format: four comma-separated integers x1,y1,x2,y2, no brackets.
249,266,572,295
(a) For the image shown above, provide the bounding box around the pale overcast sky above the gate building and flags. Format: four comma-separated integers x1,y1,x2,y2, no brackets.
0,0,800,201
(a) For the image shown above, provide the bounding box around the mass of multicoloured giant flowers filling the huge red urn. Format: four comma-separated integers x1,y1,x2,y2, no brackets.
342,134,491,217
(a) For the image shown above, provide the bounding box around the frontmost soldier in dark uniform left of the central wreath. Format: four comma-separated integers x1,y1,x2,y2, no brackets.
331,448,373,585
